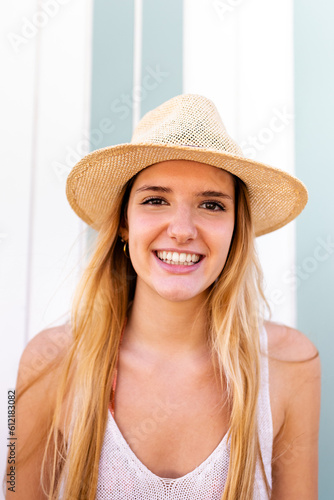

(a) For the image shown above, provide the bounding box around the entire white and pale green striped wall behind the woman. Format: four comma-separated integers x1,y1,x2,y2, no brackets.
0,0,334,500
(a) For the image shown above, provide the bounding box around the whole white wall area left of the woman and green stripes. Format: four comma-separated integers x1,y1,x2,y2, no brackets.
0,0,92,490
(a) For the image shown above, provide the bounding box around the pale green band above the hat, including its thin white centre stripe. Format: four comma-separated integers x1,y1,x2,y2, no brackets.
91,0,183,149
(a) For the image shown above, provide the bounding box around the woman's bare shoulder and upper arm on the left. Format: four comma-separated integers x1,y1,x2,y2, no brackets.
6,325,71,500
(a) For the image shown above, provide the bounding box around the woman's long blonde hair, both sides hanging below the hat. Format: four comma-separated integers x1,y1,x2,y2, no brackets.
17,171,263,500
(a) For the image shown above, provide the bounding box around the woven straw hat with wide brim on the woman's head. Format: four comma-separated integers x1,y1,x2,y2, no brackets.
66,94,307,236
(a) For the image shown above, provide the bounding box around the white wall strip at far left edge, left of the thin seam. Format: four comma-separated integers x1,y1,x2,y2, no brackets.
0,0,36,486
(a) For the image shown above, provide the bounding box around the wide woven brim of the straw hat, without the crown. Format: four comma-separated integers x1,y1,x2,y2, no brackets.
66,143,308,236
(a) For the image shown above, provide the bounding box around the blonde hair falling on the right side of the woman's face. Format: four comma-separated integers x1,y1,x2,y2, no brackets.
209,180,269,500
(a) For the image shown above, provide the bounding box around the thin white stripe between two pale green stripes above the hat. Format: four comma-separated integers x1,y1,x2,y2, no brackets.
132,0,143,129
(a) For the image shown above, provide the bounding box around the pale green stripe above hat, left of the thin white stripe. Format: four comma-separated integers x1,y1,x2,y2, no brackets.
91,0,134,150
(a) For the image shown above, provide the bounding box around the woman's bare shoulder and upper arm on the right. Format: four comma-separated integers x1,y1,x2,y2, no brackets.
265,322,321,500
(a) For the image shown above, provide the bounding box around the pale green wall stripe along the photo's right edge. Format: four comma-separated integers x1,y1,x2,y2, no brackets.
294,0,334,500
